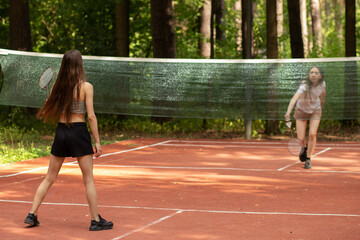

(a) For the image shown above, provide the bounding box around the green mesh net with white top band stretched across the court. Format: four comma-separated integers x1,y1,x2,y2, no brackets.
0,49,360,120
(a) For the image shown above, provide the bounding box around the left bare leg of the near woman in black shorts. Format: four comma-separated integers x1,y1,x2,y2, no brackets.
30,154,65,216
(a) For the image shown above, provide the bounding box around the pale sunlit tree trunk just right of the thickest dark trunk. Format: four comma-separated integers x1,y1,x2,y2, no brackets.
199,0,211,58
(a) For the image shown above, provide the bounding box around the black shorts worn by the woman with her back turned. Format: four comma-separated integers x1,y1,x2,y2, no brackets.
51,122,94,157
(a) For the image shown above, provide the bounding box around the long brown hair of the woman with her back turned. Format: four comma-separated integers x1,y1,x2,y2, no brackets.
36,50,86,124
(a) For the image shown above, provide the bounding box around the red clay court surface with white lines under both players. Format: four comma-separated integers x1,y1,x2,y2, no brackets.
0,139,360,240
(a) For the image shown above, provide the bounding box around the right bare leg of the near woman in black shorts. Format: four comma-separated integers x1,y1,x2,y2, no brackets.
77,155,99,221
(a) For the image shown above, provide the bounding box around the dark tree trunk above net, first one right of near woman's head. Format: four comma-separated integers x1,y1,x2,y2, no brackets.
115,0,130,57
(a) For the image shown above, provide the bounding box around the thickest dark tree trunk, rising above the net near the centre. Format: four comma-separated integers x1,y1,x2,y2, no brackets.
150,0,176,58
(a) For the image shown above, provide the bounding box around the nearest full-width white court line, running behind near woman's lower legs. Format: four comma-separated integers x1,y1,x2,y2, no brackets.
0,199,360,217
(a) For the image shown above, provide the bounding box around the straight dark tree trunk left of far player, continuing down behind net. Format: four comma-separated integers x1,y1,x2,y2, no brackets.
265,0,279,135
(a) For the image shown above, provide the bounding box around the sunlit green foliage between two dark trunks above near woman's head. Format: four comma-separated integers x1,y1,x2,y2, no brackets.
30,0,115,56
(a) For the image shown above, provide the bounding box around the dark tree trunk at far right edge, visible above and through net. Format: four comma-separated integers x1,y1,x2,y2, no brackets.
344,0,359,125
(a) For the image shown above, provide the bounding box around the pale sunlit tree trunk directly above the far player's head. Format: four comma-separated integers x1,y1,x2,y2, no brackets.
310,0,322,54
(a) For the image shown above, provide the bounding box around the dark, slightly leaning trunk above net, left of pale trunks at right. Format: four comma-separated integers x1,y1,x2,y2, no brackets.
288,0,304,58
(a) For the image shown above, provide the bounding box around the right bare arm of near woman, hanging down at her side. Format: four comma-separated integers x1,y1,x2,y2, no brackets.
84,82,101,157
